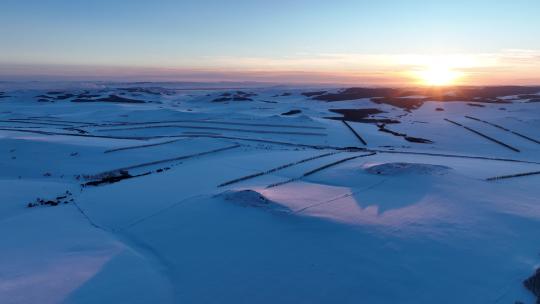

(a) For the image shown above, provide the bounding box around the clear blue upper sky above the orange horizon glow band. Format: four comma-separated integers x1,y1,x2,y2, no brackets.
0,0,540,83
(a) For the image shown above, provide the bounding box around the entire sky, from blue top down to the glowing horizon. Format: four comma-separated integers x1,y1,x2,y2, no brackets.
0,0,540,85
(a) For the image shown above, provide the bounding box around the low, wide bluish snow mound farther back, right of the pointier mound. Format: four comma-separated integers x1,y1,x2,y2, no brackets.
365,163,450,175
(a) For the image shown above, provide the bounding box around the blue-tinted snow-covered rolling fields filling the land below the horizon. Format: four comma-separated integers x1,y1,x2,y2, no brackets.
0,83,540,304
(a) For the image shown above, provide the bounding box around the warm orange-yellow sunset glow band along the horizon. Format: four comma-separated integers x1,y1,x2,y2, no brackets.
4,50,540,87
